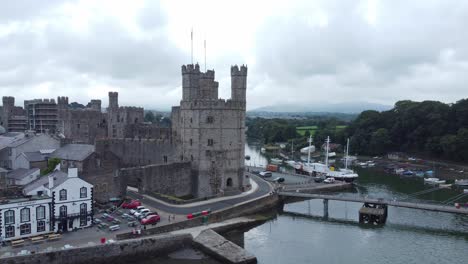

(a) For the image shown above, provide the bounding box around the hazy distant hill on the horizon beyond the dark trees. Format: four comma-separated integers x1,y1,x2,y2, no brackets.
252,102,393,114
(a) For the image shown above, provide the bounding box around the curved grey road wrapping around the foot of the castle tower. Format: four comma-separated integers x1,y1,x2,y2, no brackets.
128,174,272,215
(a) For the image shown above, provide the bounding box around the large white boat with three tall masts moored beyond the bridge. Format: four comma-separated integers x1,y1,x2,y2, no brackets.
294,137,359,182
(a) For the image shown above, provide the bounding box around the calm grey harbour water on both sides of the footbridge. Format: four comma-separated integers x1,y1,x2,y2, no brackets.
244,143,468,264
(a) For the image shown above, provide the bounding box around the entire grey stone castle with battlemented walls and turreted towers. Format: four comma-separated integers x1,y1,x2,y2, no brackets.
0,64,247,197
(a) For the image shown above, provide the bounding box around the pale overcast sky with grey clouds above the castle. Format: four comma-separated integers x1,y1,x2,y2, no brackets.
0,0,468,109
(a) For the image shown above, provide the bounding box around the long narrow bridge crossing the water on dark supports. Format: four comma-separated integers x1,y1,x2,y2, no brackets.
278,192,468,224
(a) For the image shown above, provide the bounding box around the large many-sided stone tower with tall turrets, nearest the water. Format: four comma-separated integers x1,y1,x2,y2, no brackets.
172,65,247,197
